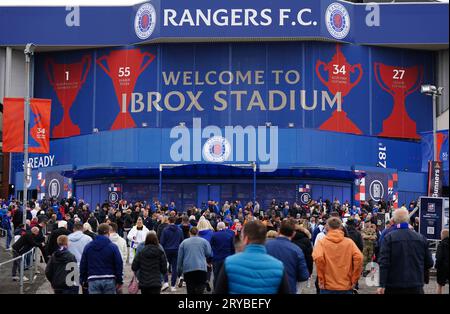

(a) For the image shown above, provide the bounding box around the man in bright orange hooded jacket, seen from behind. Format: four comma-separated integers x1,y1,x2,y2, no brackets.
313,217,363,294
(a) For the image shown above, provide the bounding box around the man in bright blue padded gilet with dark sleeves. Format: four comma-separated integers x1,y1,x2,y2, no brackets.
214,220,289,294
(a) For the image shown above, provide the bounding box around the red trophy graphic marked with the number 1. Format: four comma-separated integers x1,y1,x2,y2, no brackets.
45,55,91,138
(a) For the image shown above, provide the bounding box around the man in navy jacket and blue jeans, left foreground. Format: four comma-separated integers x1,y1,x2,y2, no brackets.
80,223,123,294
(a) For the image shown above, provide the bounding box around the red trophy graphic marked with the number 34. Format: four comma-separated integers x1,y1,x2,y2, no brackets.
316,44,363,134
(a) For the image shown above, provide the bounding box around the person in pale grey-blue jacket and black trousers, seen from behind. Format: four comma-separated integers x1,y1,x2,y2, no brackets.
177,227,212,294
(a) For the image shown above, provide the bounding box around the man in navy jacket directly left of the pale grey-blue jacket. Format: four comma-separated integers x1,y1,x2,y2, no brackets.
160,216,184,292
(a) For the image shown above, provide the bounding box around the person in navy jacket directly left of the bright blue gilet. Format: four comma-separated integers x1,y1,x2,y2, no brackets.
211,221,235,285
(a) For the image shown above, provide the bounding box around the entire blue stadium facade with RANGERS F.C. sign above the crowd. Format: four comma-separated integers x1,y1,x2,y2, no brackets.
0,0,448,208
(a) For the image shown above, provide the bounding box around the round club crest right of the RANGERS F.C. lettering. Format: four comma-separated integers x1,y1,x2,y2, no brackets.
325,2,350,39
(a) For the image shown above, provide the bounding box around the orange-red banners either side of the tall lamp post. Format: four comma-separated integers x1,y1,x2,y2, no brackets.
3,98,51,154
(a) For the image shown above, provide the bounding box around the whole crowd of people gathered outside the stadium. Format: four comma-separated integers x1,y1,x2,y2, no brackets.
0,198,449,294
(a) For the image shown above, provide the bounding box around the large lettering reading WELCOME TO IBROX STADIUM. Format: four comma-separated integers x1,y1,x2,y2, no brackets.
120,69,342,113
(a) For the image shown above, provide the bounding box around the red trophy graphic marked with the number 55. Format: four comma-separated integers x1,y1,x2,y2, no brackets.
97,48,155,130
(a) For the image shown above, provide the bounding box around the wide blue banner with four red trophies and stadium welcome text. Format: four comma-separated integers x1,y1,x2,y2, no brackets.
35,42,434,140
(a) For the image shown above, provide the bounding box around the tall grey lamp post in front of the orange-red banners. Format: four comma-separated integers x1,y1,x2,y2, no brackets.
23,43,36,227
